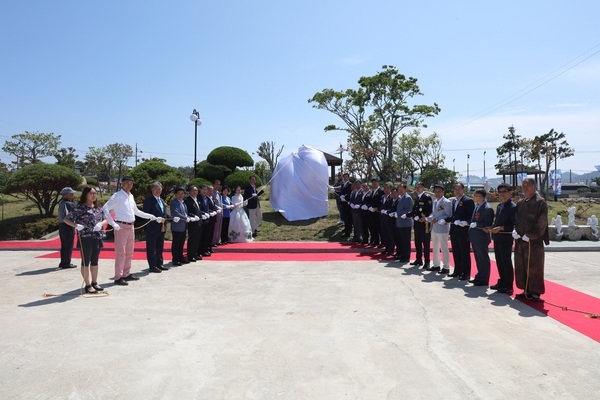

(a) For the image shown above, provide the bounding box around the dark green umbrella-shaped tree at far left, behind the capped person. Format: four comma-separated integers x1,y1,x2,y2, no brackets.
5,163,81,217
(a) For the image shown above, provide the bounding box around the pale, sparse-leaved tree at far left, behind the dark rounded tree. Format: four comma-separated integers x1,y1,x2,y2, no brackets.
2,131,60,168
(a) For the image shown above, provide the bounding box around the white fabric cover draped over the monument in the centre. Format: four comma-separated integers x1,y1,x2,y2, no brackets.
271,146,329,221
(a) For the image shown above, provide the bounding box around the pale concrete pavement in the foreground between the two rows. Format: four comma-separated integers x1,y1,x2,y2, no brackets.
0,247,600,400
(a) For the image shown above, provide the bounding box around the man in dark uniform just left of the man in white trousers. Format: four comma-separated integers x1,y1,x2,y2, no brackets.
406,182,433,271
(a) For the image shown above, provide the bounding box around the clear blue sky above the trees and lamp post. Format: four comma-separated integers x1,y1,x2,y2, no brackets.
0,0,600,177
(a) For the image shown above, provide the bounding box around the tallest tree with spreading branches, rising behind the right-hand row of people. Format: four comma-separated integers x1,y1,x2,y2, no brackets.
308,65,440,179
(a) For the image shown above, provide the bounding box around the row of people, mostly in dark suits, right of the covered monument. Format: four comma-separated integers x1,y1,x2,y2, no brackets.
330,174,549,301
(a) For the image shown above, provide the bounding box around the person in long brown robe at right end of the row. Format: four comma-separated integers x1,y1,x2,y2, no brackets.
513,178,549,301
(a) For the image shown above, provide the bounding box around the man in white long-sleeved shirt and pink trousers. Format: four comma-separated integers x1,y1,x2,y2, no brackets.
103,176,163,286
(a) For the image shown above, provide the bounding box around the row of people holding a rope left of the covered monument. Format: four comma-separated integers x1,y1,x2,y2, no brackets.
59,176,262,293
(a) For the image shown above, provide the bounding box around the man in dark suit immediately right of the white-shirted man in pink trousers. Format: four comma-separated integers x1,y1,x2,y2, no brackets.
142,182,169,273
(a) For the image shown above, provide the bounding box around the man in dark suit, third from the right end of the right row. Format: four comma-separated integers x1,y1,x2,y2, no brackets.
469,189,494,286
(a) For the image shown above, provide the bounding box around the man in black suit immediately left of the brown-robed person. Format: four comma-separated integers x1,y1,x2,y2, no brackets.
490,183,517,295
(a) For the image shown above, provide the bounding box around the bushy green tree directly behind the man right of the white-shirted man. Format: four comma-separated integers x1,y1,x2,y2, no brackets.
131,161,187,199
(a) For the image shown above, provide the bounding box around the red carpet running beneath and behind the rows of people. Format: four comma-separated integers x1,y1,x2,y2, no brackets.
5,239,600,342
